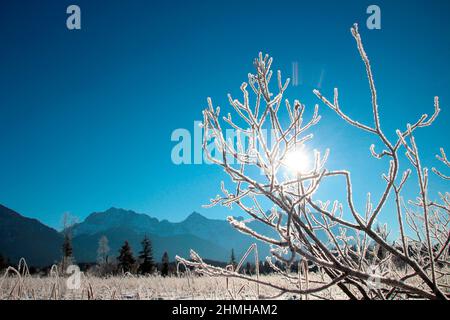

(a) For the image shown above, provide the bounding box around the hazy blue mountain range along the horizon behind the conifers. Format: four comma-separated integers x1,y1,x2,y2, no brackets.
0,205,273,266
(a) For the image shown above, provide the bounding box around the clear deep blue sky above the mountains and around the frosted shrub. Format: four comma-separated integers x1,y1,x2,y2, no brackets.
0,0,450,227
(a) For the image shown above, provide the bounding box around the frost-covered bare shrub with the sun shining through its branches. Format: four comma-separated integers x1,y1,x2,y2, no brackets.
177,24,450,299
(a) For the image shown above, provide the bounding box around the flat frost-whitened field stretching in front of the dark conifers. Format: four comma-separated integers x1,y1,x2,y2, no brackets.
0,274,345,300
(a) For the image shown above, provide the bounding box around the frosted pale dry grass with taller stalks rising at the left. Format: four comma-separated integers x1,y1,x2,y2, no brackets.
0,259,450,300
